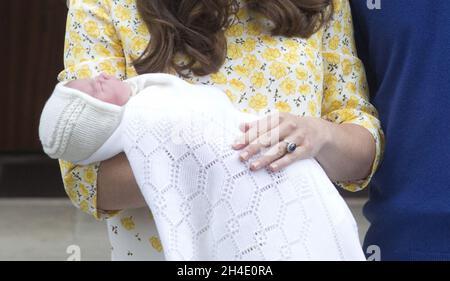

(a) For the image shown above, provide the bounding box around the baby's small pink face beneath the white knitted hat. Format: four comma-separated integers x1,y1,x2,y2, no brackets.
66,74,131,106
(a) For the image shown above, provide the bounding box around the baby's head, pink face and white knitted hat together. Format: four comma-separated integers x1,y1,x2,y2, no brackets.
39,74,133,163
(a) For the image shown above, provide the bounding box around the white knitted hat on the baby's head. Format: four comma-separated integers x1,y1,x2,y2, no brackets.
39,82,123,163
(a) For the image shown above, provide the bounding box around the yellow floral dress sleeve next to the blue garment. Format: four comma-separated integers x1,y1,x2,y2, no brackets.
322,0,384,192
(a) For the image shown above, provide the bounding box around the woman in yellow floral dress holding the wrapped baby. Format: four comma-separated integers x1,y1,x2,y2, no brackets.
59,0,382,259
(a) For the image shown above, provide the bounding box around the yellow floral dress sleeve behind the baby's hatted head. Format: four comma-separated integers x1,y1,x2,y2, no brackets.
58,0,126,220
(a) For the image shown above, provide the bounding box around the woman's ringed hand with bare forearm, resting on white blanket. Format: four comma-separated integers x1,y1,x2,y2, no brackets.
233,113,376,181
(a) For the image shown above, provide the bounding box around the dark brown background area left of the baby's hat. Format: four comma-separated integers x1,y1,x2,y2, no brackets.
0,0,366,198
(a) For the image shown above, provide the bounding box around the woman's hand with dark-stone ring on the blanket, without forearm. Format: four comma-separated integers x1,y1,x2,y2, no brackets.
233,113,331,172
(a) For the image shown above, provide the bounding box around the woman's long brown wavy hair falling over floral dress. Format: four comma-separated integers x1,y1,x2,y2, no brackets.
134,0,333,76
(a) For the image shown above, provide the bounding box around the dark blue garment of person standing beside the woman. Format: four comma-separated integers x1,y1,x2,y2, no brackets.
350,0,450,260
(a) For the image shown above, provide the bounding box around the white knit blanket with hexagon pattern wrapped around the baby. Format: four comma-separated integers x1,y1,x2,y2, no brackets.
83,75,364,260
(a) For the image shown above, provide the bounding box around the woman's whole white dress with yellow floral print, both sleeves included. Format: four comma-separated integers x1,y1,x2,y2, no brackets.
58,0,383,260
